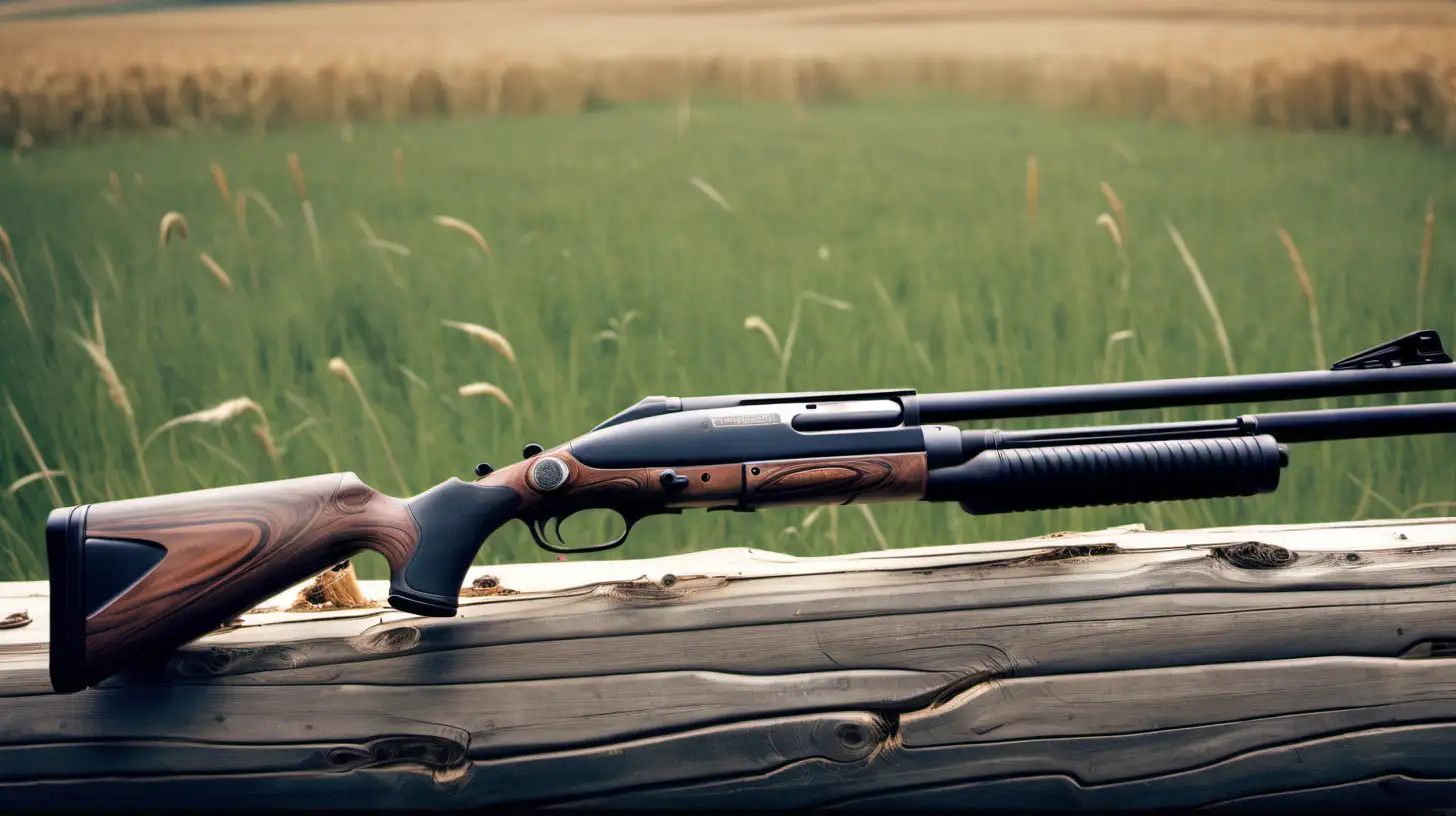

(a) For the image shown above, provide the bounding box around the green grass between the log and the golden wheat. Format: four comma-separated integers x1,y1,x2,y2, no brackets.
0,99,1456,578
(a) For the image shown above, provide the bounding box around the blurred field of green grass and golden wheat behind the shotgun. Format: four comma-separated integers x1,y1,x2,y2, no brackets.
0,0,1456,580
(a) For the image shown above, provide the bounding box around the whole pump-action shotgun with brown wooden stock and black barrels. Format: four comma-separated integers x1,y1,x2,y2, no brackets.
45,329,1456,694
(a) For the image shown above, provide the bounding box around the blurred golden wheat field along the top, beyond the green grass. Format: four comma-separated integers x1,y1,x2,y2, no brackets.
0,0,1456,150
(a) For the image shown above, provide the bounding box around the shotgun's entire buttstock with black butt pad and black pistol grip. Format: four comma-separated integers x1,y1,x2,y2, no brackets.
45,474,518,694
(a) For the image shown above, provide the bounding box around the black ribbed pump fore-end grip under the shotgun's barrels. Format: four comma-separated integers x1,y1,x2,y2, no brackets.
942,436,1289,516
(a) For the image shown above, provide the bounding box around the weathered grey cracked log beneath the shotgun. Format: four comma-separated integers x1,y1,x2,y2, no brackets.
0,519,1456,812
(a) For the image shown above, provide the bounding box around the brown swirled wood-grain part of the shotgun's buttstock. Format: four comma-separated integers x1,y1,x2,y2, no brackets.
86,474,418,681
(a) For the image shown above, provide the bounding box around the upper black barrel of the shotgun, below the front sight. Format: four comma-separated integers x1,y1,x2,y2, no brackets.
916,363,1456,422
